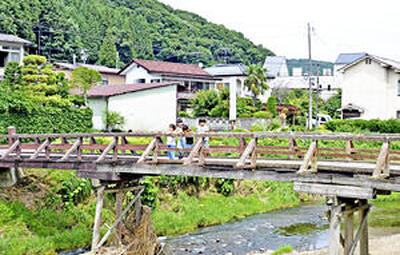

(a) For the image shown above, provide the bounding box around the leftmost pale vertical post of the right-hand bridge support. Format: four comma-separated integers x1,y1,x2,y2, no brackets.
329,197,341,255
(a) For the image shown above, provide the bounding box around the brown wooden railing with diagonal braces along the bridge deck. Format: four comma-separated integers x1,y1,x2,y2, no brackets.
0,128,400,178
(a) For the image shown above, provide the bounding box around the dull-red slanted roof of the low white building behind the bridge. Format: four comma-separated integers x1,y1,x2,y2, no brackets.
71,82,177,97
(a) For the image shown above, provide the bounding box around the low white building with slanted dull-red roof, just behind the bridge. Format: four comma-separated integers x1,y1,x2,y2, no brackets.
75,82,177,131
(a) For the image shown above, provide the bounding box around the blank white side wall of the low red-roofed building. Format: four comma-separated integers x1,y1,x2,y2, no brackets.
108,86,177,131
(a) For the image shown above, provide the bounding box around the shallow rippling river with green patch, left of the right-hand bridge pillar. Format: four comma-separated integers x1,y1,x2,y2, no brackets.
159,205,328,255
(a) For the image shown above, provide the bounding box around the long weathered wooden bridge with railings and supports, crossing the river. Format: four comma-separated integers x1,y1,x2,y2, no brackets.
0,128,400,255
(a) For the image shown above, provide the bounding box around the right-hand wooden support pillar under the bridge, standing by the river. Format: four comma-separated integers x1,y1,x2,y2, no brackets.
327,197,370,255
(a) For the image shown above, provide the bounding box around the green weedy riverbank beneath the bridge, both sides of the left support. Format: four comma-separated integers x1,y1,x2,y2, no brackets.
0,170,300,254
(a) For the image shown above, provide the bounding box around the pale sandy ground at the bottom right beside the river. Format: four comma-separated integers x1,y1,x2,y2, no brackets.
248,234,400,255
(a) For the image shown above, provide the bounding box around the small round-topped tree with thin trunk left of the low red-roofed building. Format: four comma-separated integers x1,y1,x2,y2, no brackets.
71,66,102,106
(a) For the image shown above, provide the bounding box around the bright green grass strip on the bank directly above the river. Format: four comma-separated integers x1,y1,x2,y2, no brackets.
152,182,300,236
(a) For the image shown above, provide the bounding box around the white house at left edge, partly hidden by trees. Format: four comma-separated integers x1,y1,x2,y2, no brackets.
0,33,32,80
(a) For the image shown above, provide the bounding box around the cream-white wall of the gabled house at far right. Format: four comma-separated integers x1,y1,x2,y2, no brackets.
342,61,400,119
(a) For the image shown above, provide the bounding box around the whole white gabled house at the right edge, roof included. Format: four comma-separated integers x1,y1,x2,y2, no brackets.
339,55,400,119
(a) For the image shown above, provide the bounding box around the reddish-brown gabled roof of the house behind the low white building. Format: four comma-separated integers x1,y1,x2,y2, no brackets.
120,59,212,78
